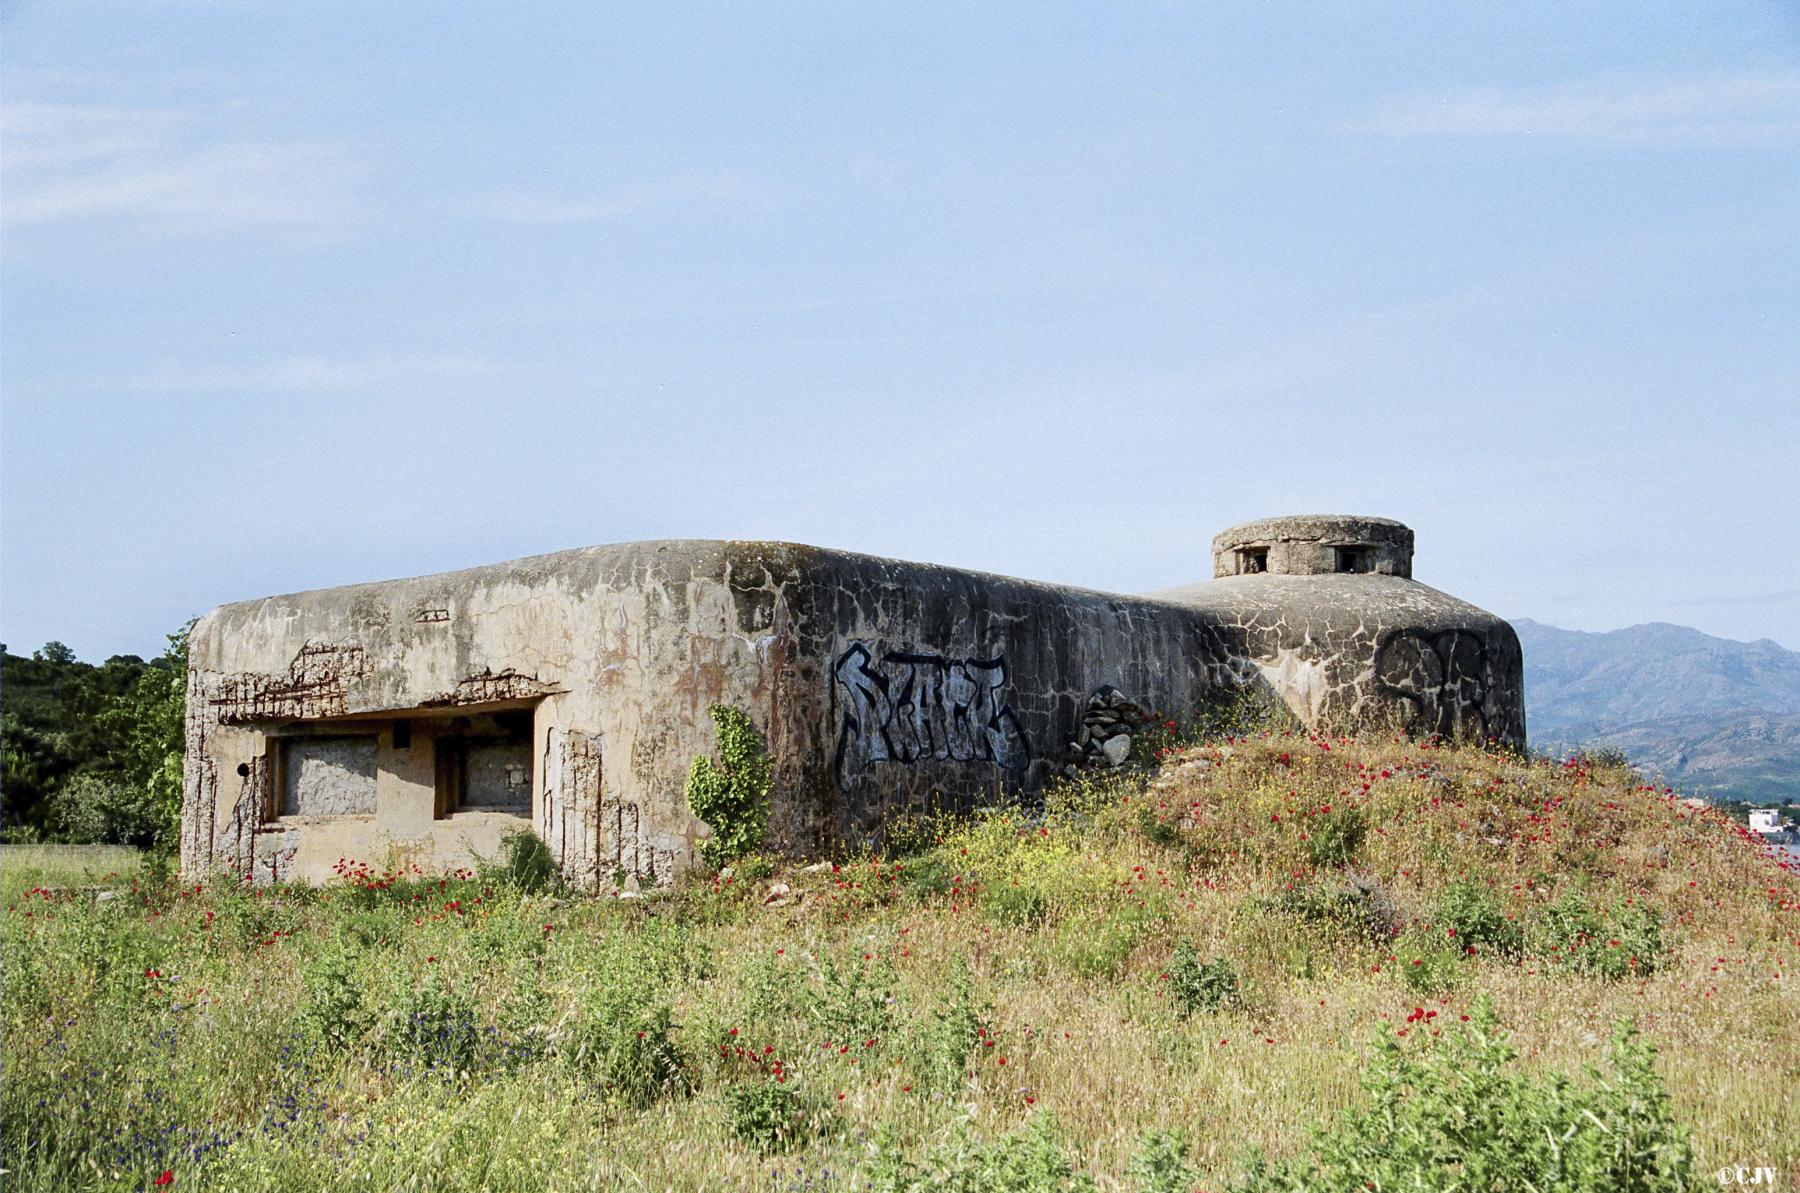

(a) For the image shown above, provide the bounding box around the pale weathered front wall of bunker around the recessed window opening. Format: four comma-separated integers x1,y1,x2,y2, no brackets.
182,543,769,884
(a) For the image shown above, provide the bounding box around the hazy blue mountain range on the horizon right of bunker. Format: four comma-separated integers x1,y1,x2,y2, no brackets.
1512,617,1800,803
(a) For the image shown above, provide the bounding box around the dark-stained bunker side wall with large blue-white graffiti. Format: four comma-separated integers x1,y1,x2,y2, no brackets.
734,552,1260,853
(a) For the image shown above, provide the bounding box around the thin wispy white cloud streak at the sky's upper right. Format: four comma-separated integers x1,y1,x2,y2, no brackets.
1345,72,1800,146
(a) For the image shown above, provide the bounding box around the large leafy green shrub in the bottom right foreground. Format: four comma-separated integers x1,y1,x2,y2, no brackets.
1235,1000,1694,1193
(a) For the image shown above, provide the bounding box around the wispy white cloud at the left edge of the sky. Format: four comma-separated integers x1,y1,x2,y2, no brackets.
0,103,346,232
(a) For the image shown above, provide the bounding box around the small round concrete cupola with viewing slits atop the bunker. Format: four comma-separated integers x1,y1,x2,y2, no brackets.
1213,515,1413,579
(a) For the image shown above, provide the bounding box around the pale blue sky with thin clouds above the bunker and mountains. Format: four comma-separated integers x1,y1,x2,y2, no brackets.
0,2,1800,659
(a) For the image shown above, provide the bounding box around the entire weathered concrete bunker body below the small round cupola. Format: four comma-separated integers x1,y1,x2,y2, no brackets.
182,527,1523,887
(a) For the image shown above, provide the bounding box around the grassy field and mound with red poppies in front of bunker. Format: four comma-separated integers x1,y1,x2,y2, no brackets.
0,732,1800,1191
